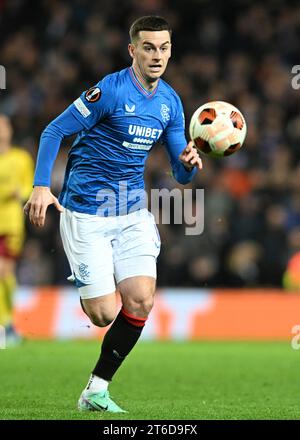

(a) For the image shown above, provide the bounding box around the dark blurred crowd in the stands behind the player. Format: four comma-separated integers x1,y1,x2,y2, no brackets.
0,0,300,287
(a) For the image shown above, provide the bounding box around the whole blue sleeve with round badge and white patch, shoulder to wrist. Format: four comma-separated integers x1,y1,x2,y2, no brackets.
34,75,117,186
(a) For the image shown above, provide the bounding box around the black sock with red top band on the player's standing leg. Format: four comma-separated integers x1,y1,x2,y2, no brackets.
92,308,146,381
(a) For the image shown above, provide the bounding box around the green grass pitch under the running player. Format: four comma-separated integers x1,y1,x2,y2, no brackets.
0,341,300,420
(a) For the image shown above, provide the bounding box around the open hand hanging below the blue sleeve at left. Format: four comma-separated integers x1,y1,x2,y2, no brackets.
24,186,64,228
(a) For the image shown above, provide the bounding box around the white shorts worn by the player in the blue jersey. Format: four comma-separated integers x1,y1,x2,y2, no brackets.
60,209,160,299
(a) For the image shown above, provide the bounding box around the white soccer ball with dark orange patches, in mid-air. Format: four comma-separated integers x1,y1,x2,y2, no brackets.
190,101,247,157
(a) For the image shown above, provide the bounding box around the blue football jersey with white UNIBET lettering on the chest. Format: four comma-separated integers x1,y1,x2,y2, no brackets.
37,67,196,216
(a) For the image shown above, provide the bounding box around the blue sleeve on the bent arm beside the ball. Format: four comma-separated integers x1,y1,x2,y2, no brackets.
163,99,197,185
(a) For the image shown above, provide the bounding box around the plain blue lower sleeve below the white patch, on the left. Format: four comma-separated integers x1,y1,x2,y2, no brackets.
34,107,84,186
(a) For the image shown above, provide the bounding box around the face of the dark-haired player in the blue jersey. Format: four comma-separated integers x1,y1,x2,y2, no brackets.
129,31,171,84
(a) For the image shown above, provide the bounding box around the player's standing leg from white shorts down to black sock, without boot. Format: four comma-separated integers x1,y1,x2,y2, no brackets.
79,211,160,412
